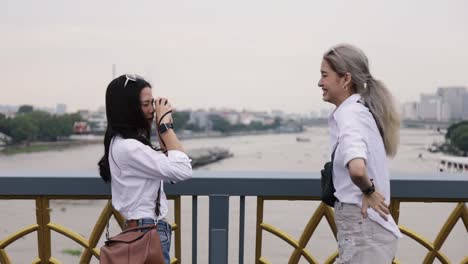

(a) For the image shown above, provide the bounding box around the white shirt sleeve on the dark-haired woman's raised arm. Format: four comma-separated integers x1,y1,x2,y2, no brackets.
119,139,192,182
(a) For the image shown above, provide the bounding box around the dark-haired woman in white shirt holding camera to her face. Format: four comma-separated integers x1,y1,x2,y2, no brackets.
98,74,192,263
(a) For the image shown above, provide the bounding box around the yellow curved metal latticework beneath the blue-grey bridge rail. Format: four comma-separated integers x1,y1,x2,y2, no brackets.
0,196,468,264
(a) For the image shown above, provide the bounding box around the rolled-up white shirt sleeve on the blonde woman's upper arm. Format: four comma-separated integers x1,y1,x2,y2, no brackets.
337,108,368,167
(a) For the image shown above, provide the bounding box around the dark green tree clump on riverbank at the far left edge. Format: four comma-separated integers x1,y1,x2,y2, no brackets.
0,110,81,143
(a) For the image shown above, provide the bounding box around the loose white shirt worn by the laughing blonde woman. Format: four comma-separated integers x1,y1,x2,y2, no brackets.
328,94,402,237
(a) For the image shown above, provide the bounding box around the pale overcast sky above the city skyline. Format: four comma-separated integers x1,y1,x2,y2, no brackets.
0,0,468,113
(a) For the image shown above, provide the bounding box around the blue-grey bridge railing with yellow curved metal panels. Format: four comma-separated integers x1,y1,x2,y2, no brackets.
0,171,468,264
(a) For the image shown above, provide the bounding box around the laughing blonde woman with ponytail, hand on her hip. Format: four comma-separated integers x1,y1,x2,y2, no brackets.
318,44,402,264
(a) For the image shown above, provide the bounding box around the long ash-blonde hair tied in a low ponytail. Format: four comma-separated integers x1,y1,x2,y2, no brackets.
323,44,400,157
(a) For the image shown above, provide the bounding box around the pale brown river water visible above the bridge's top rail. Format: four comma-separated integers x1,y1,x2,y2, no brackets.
0,127,443,173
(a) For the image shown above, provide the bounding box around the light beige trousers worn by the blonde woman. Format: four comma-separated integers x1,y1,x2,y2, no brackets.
335,202,398,264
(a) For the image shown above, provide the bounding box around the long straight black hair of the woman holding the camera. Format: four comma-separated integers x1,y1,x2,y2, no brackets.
98,75,152,182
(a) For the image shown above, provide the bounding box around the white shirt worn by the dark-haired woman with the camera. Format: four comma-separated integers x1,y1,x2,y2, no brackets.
109,136,192,219
